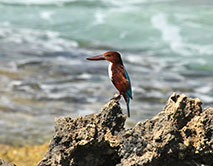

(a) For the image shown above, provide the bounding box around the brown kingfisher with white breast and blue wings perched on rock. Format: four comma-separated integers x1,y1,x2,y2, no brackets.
87,51,132,117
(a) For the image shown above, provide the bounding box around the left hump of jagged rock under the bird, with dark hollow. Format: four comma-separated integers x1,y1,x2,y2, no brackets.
38,100,126,166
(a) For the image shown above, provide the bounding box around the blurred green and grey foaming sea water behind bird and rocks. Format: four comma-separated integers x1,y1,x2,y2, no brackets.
0,0,213,145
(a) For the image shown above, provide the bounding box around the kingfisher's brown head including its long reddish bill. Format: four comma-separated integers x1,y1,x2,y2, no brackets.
87,51,122,64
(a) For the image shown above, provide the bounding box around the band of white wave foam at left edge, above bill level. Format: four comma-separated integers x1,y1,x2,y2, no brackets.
0,28,78,51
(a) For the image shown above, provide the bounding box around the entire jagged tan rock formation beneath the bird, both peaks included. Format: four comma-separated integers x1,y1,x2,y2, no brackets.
38,93,213,166
